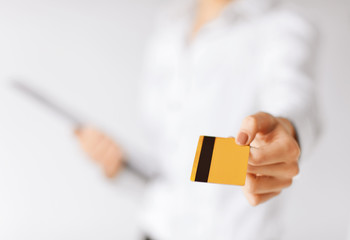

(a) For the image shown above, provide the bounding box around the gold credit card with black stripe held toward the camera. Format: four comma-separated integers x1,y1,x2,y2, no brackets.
191,136,250,186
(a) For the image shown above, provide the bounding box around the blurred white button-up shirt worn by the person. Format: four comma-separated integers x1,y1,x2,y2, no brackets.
124,0,316,240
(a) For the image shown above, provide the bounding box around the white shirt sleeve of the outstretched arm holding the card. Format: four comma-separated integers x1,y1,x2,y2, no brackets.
258,10,319,159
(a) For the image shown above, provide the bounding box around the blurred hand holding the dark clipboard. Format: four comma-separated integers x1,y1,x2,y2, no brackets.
75,127,123,178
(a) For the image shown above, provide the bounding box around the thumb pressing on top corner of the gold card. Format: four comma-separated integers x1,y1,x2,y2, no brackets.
236,112,277,145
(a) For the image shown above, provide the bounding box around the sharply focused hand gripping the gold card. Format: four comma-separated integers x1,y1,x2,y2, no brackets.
236,112,300,206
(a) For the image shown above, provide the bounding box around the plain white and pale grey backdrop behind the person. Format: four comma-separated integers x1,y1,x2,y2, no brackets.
0,0,350,240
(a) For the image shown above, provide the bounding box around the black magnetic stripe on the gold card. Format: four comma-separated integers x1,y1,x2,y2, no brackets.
195,136,215,182
